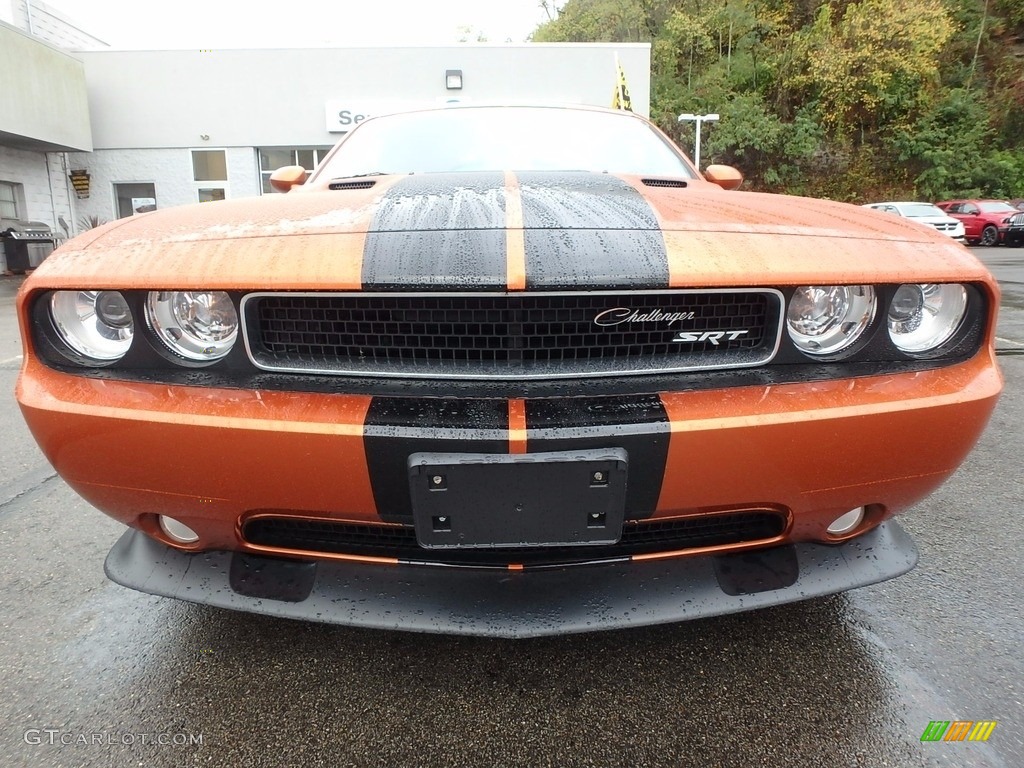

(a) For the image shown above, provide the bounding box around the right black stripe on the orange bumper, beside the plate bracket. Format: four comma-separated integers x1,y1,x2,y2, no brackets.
526,394,671,519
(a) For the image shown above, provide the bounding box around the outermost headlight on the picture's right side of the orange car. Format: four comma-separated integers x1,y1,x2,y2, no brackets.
889,283,967,352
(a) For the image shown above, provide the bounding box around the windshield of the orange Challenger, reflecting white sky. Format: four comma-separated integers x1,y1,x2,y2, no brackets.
314,106,694,178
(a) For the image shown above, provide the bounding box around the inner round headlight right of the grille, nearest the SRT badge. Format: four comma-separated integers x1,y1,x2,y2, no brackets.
785,286,878,356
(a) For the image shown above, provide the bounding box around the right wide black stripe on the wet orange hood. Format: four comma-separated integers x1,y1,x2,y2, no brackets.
516,172,669,290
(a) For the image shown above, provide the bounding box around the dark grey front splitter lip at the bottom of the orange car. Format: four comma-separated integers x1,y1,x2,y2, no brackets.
104,520,918,638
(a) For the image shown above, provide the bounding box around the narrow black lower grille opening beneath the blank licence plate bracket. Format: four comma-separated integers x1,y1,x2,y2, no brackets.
243,511,785,567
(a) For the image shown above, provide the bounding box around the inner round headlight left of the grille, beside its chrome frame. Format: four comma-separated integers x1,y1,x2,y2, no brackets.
145,291,239,362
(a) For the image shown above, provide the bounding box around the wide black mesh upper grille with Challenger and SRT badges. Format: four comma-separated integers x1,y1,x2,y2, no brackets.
246,291,780,378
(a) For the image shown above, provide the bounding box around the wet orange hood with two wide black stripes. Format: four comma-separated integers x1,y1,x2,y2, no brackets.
29,172,984,290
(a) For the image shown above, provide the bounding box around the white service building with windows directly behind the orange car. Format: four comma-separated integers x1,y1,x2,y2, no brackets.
69,44,650,225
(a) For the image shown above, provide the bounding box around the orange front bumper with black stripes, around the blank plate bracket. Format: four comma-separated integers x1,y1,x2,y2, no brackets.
17,352,1001,557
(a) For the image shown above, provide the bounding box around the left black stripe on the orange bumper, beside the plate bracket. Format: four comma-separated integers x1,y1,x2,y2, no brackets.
362,397,509,525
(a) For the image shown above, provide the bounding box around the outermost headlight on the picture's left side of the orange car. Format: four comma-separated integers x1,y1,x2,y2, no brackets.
50,291,135,366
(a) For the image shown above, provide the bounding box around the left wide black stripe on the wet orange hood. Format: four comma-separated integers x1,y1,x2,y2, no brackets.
362,173,506,291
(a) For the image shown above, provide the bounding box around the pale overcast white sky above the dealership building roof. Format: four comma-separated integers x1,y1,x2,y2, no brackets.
43,0,547,49
